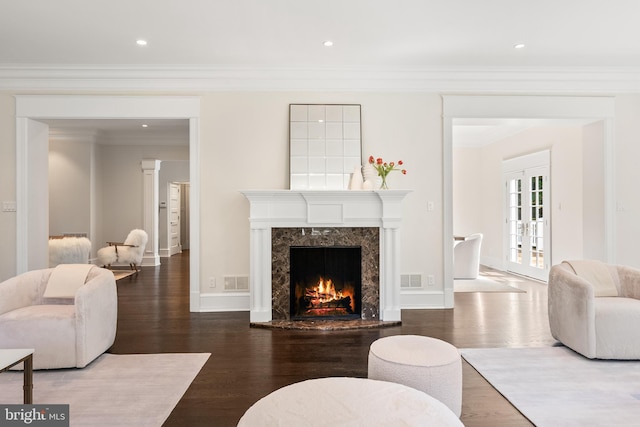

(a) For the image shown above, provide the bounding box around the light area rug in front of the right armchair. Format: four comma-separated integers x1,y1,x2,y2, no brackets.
460,347,640,427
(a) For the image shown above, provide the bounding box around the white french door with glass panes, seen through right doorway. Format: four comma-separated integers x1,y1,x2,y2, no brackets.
503,152,551,281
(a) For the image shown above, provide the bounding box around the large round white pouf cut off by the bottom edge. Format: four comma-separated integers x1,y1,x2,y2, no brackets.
238,377,464,427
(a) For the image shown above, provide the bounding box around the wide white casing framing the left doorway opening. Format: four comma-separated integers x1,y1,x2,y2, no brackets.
16,95,201,312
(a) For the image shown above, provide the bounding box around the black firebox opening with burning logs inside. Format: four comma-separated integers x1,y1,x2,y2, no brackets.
290,246,362,320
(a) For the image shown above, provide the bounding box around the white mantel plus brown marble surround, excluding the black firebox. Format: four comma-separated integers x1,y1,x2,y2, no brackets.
242,190,410,324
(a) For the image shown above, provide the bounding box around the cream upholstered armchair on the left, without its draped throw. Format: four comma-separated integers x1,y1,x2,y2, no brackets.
0,266,118,369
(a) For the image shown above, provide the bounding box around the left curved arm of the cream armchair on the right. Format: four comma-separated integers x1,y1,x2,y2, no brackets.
548,264,596,357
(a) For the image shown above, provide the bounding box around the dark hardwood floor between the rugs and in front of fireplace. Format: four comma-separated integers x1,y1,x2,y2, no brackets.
109,252,555,427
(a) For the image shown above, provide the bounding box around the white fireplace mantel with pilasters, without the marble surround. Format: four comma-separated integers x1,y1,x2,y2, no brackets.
242,190,410,322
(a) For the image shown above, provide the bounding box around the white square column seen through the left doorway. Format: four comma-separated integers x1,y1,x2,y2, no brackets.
141,159,160,266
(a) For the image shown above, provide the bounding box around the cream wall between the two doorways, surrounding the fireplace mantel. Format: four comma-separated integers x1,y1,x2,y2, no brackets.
200,92,443,300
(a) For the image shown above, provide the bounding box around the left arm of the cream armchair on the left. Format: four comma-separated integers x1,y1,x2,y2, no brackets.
0,269,51,314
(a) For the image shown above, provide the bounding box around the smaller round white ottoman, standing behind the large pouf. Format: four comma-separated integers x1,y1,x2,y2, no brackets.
368,335,462,417
